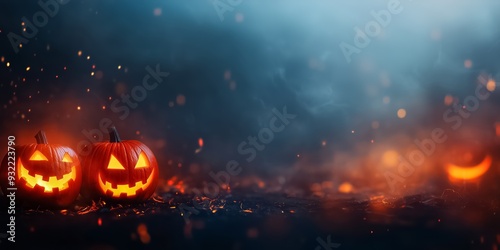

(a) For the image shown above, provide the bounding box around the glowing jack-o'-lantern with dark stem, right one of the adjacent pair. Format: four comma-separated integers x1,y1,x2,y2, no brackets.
82,127,159,202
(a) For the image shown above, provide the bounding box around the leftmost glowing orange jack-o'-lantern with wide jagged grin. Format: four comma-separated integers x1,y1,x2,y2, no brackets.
0,131,82,207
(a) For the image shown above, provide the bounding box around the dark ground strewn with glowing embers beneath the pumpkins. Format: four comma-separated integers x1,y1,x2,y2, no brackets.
0,190,500,250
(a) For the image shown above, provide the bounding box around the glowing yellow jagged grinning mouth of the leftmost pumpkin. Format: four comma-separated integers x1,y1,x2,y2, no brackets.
19,160,76,193
